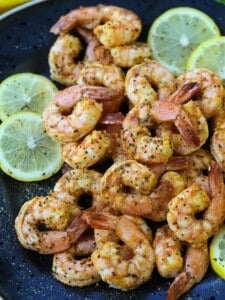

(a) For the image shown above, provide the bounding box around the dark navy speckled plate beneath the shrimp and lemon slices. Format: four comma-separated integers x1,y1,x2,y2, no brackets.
0,0,225,300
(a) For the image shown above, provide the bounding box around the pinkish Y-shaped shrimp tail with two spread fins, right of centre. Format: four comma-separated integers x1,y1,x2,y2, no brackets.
151,82,200,146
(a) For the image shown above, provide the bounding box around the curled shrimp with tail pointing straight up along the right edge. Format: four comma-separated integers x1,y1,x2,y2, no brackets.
167,161,225,243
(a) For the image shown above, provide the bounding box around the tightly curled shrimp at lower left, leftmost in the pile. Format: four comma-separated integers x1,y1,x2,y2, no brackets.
15,196,76,254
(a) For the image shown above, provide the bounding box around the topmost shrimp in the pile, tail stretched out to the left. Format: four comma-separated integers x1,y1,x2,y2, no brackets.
50,5,142,48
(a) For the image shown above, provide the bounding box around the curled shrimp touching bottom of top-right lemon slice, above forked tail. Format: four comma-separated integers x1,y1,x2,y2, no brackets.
125,59,176,105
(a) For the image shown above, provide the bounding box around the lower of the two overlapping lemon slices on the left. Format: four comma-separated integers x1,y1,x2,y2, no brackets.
0,112,62,181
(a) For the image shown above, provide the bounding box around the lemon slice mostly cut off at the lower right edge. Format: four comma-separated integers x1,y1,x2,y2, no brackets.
209,225,225,279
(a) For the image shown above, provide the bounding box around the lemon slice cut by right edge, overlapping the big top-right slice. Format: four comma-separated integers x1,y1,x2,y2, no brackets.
187,36,225,82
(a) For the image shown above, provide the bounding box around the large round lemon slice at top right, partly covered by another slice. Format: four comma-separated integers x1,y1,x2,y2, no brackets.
147,7,220,75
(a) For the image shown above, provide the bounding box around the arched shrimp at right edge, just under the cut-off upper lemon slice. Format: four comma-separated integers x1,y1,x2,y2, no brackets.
176,69,224,119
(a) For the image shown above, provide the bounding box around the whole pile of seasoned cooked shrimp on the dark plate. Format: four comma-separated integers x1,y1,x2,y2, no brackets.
15,5,225,299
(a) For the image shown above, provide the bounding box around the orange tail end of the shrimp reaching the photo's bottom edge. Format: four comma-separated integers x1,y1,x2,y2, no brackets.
166,241,209,300
